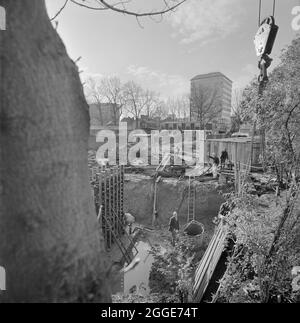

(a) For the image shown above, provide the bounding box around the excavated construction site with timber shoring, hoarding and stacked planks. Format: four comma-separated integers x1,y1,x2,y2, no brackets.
89,131,282,301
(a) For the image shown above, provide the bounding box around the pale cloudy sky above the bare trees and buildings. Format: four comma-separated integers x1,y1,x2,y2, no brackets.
46,0,300,97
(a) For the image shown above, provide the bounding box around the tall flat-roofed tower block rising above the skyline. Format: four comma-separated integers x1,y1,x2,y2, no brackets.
190,72,232,133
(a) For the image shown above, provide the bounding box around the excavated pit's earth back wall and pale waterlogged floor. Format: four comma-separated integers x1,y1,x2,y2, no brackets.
113,174,230,296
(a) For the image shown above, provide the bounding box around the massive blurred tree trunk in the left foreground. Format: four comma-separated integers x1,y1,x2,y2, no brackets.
0,0,110,302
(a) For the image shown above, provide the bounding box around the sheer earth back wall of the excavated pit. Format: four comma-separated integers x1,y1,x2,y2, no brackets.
124,174,225,234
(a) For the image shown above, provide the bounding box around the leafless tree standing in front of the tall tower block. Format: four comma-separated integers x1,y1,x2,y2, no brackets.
190,86,222,128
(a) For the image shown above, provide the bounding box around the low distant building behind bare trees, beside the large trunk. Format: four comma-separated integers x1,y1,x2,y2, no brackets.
89,103,120,129
